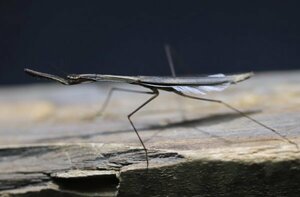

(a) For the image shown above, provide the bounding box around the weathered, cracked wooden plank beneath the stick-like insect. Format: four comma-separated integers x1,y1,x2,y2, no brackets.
0,71,300,196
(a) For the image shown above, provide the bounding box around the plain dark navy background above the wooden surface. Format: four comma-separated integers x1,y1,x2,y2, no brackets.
0,0,300,85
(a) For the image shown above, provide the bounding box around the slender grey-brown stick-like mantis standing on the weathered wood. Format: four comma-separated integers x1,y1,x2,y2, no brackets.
24,48,298,169
